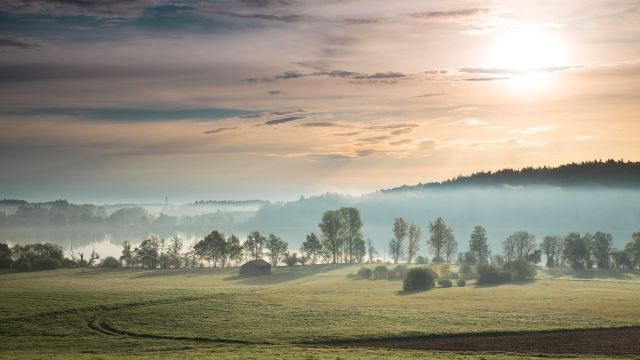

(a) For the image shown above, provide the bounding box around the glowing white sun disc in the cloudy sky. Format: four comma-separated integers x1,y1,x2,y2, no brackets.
486,31,568,88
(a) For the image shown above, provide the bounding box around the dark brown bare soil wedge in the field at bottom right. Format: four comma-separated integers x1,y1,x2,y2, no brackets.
335,327,640,356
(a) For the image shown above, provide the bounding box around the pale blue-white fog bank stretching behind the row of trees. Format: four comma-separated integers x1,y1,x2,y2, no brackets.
0,186,640,256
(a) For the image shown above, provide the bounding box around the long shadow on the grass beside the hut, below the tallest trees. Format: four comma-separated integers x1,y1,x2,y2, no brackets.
224,264,351,285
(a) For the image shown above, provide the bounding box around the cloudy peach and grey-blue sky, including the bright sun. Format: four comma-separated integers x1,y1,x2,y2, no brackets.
0,0,640,203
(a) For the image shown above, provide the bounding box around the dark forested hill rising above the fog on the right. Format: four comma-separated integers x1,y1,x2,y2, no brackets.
381,160,640,192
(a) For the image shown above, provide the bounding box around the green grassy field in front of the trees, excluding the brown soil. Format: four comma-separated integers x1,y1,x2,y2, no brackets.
0,265,640,359
